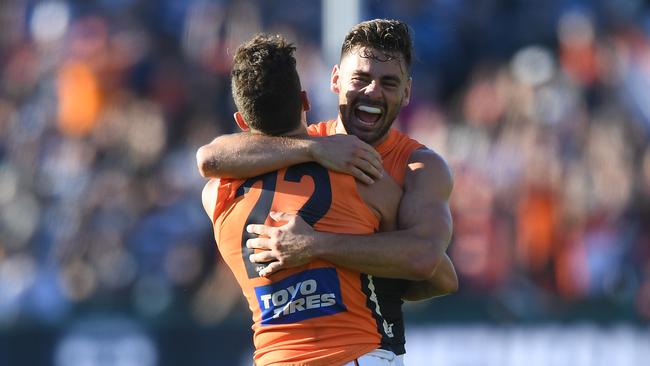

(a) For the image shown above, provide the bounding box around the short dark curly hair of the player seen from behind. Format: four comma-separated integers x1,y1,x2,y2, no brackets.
231,34,302,135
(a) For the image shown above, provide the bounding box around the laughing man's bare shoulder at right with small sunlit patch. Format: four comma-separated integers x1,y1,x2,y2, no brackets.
404,147,454,197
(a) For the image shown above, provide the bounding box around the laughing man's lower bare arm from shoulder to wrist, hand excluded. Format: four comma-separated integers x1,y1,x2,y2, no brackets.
315,150,452,280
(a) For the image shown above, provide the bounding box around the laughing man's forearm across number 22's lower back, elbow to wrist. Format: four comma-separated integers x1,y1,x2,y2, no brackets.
313,230,446,280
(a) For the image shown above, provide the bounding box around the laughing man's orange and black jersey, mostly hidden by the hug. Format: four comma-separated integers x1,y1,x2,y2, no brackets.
307,120,424,355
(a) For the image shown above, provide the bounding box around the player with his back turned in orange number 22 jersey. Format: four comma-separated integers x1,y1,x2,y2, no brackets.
203,30,408,366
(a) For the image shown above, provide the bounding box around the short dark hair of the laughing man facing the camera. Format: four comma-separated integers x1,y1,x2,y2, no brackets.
341,19,413,69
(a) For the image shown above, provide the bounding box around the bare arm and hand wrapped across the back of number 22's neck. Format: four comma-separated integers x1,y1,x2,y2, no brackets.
196,132,383,184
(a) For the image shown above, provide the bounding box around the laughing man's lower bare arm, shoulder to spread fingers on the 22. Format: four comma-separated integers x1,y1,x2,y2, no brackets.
248,150,453,280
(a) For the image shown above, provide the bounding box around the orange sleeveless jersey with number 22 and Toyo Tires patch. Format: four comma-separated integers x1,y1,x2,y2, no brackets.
212,163,388,366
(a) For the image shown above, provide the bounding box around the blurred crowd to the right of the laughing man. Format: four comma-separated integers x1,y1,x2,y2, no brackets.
394,2,650,320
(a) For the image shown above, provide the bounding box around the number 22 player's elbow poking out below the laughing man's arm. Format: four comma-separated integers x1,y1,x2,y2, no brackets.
402,254,458,301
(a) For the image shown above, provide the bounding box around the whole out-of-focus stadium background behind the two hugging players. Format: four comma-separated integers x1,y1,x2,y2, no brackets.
0,0,650,366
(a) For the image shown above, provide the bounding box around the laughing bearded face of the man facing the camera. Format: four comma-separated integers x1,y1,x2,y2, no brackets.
330,47,411,145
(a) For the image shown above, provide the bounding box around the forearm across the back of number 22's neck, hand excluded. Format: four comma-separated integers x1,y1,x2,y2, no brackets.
196,133,313,178
